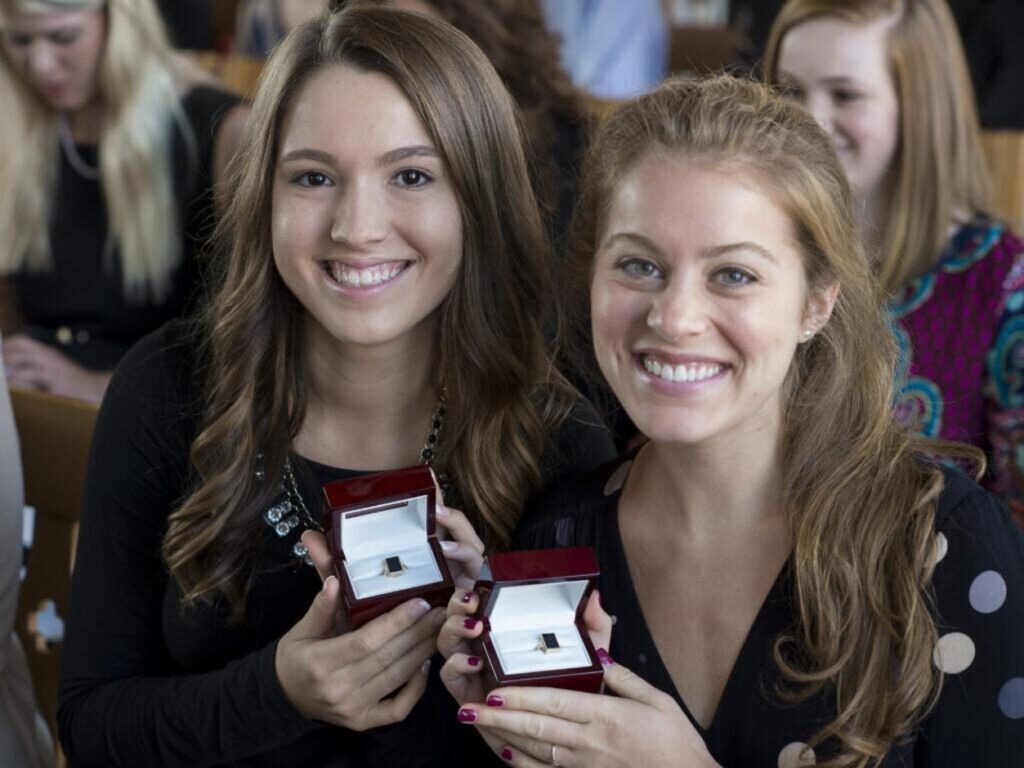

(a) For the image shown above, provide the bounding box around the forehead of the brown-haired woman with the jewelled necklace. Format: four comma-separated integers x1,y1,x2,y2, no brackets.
281,66,433,156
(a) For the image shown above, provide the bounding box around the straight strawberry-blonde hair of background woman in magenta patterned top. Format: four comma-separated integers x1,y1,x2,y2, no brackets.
765,0,991,294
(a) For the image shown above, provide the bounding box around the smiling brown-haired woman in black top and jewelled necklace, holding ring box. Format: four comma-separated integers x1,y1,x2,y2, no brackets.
58,5,611,766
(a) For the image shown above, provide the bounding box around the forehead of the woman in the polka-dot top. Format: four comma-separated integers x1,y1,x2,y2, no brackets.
603,155,797,256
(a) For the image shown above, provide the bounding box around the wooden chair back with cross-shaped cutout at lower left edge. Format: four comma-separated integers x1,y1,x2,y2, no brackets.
12,387,98,766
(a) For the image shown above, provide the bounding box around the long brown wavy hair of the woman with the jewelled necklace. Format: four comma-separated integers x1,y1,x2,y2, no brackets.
164,4,573,618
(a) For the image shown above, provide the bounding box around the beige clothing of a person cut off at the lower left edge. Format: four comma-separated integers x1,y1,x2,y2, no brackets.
0,342,53,768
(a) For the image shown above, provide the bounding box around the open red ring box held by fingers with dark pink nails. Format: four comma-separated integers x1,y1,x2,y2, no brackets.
473,547,604,693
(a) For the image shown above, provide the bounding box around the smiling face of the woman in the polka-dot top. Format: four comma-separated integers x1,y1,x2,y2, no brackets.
591,156,831,444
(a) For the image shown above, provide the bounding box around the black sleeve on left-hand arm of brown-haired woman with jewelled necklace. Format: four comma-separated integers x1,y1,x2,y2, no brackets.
57,332,316,768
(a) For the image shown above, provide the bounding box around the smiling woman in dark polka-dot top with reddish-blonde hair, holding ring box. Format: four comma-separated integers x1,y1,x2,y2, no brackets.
439,77,1024,768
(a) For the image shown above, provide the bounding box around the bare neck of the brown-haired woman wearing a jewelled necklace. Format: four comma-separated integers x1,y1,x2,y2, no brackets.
295,318,438,470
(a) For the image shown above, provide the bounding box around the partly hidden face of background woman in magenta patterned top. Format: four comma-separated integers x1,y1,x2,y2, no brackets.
777,17,900,198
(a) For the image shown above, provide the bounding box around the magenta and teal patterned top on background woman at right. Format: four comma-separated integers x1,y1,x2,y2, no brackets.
890,217,1024,525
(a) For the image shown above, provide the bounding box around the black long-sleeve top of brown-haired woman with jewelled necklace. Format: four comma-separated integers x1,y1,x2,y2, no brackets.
58,324,612,768
